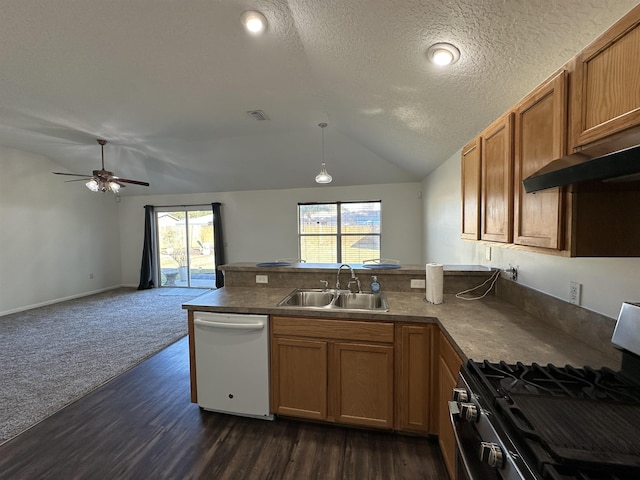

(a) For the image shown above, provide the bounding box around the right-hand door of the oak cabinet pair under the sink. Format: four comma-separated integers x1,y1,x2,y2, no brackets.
329,343,394,429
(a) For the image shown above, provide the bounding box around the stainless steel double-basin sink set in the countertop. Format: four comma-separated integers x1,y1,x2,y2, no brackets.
278,288,389,312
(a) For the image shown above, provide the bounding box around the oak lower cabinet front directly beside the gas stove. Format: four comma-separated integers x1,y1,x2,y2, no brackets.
437,332,462,478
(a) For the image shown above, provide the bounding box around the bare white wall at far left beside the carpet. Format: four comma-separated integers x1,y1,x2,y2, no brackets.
0,147,121,315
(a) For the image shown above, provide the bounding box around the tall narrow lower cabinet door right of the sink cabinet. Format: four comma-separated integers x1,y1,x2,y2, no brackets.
396,324,433,433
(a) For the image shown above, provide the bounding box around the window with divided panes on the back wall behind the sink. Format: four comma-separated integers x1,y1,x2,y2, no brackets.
298,200,382,263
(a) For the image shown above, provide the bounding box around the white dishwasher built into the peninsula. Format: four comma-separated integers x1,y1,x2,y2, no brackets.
193,311,273,420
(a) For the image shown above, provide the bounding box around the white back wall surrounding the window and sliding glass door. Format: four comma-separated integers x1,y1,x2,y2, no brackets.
118,183,423,285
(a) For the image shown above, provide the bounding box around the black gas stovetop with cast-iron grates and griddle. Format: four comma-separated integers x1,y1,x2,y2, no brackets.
460,360,640,480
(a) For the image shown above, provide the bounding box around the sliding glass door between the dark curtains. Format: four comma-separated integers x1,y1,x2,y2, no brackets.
156,209,216,288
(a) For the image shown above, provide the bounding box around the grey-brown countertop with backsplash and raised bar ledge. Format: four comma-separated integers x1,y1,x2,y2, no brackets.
183,263,619,369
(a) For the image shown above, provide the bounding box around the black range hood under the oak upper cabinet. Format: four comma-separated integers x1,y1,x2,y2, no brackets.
522,145,640,193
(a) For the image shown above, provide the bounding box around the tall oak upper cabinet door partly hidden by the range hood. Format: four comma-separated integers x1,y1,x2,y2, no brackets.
513,71,567,250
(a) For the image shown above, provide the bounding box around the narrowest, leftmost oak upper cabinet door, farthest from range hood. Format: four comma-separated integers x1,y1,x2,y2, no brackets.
461,137,481,240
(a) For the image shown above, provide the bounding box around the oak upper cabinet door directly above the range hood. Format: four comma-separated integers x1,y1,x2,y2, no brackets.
570,5,640,150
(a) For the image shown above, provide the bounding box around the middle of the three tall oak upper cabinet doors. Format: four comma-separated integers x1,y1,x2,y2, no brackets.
480,113,513,243
